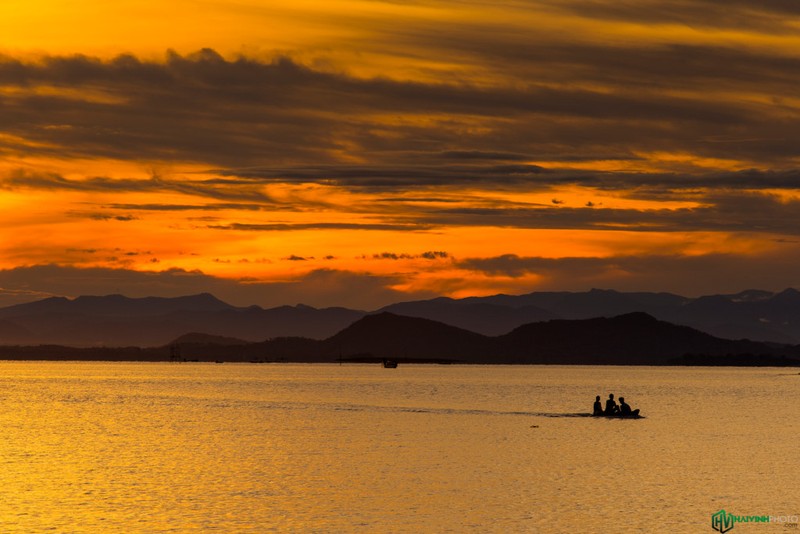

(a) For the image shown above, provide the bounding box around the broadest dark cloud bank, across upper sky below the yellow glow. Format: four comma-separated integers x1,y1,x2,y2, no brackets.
0,45,798,176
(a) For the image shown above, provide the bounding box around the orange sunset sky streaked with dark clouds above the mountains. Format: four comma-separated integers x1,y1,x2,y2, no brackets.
0,0,800,309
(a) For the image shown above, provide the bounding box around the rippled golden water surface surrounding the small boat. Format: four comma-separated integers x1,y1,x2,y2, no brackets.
0,362,800,533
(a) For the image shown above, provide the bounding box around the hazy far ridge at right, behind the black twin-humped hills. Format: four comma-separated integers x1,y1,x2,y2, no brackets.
374,289,800,344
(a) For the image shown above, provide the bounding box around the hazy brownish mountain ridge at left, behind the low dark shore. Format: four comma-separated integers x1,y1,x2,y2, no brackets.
0,294,364,347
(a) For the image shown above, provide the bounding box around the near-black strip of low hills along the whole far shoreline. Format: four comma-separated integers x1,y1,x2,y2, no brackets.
0,312,800,366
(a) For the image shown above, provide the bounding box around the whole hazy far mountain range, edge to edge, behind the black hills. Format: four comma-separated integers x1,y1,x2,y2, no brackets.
0,289,800,347
